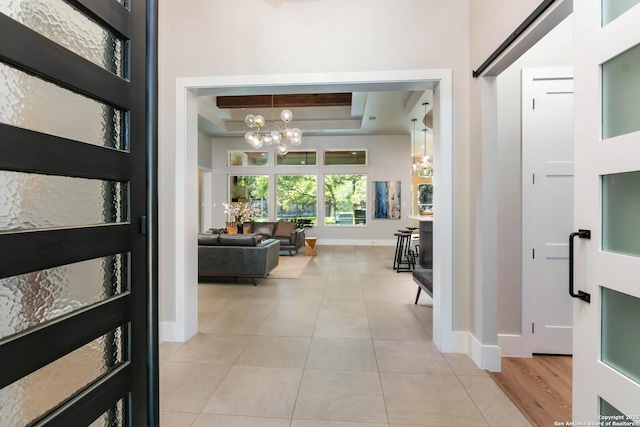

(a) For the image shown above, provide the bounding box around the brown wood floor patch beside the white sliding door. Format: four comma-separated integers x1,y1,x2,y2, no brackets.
490,355,573,427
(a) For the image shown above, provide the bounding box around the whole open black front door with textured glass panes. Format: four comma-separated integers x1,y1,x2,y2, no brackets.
0,0,158,426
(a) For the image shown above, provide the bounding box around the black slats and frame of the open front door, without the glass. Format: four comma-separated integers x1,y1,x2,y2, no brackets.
0,0,159,426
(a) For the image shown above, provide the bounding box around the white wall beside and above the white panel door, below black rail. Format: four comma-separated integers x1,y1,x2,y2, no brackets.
497,16,573,335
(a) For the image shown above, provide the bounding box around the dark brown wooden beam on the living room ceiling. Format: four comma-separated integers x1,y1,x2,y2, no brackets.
216,93,351,109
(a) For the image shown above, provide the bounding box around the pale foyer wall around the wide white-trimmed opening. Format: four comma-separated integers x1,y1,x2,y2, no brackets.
159,0,471,338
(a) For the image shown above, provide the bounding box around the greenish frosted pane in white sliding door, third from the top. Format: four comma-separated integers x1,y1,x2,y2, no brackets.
602,172,640,256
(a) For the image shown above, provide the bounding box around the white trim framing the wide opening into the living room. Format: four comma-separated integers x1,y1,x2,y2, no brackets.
167,70,460,352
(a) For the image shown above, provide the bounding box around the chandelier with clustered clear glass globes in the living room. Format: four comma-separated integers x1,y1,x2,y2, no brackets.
244,95,302,156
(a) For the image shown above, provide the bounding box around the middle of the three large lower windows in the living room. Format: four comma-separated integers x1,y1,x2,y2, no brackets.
276,175,318,224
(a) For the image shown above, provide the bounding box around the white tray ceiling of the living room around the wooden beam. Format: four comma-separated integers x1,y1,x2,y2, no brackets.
198,87,433,154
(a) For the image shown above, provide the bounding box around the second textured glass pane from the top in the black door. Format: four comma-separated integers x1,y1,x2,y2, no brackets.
0,62,127,150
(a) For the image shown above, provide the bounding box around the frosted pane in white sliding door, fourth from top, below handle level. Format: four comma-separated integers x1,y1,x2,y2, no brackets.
602,288,640,383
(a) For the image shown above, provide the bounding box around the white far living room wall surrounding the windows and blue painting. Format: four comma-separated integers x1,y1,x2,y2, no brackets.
212,135,411,245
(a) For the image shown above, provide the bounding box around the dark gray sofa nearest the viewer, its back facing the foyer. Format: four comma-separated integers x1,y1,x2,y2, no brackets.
198,234,280,286
